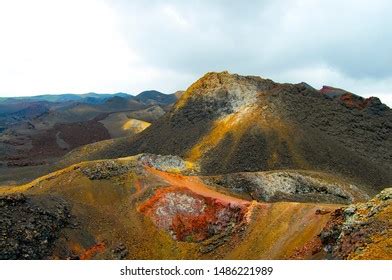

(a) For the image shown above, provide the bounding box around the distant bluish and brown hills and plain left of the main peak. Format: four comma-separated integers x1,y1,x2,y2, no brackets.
0,91,180,182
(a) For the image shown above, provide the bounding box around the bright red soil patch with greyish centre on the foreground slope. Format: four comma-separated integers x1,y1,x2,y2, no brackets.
139,187,247,242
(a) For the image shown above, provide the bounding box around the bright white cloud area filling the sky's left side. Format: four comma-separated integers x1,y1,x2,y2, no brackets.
0,0,175,96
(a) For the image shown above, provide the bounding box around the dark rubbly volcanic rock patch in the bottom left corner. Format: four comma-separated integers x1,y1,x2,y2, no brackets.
0,194,70,260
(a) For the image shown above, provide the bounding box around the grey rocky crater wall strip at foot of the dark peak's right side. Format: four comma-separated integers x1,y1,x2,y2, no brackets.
203,171,368,204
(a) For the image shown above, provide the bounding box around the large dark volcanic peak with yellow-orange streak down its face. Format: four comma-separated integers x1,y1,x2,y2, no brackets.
59,72,392,194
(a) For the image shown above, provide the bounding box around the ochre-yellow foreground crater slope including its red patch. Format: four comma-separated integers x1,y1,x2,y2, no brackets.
0,155,356,259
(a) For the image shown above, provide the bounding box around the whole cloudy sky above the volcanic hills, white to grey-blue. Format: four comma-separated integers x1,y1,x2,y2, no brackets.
0,0,392,105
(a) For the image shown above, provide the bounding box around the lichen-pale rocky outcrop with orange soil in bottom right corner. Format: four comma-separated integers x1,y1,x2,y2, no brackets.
320,188,392,259
